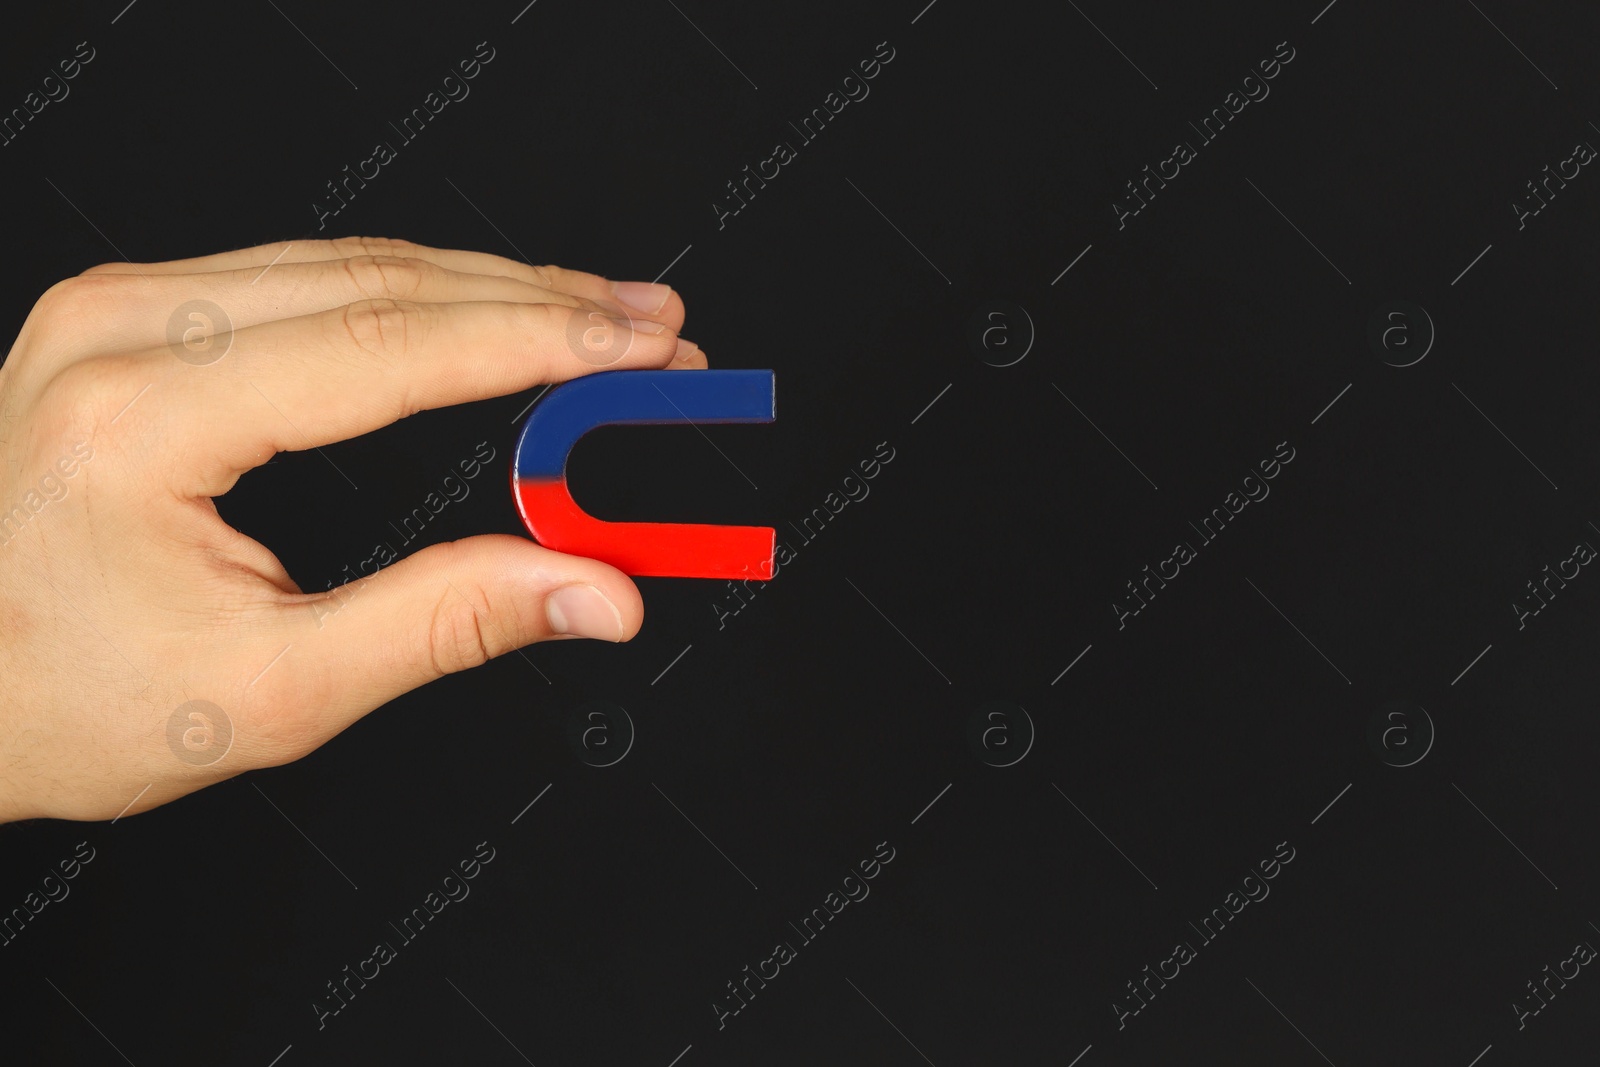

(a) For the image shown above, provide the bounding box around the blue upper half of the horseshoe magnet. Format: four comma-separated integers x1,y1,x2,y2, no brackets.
514,371,778,478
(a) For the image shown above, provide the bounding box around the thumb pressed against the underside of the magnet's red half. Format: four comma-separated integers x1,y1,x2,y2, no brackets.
284,534,645,736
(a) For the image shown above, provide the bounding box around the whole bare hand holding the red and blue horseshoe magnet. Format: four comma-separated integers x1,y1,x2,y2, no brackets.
0,238,706,822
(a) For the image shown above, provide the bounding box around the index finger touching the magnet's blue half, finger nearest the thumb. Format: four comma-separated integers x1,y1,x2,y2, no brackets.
148,299,704,496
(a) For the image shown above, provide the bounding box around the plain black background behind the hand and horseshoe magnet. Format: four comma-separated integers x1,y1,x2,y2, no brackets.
0,0,1600,1067
